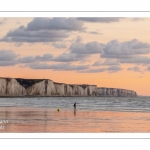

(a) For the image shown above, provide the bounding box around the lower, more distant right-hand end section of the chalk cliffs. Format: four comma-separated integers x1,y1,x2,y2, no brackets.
96,88,137,97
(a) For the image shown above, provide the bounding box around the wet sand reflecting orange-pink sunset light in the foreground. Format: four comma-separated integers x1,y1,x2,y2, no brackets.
0,107,150,133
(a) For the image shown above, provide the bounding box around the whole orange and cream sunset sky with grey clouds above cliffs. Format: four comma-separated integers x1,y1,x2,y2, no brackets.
0,17,150,96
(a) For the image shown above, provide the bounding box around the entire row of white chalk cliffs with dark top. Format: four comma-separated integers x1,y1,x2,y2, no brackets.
0,78,137,96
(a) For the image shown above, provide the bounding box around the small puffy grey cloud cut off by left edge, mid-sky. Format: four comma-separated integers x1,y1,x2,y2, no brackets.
0,50,18,61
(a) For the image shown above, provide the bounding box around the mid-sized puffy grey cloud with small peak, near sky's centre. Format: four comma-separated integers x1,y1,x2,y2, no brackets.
69,37,105,54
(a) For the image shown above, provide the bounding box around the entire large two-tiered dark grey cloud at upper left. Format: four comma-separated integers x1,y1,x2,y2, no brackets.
0,18,85,44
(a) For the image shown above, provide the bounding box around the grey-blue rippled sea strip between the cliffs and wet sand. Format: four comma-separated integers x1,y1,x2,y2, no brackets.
0,96,150,112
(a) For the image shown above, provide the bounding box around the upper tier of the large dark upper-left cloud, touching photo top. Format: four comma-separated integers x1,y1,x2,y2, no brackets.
26,17,85,31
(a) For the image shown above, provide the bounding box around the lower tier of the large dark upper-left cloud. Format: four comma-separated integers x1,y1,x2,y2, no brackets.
0,26,68,43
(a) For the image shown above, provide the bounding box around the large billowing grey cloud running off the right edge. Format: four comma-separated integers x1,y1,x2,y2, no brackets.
101,39,150,58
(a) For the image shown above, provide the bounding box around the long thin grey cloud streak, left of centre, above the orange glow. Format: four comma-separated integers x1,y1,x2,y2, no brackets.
27,63,89,71
